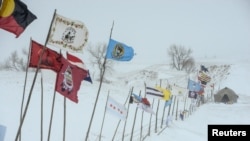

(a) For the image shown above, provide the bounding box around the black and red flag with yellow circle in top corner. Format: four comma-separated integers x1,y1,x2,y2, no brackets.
0,0,37,38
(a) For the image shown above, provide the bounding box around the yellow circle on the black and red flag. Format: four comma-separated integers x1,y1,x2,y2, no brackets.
0,0,15,17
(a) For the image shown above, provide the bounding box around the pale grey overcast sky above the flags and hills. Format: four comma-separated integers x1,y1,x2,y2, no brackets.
0,0,250,64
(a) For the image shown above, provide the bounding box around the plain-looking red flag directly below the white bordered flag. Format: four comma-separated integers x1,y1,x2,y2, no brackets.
29,41,62,72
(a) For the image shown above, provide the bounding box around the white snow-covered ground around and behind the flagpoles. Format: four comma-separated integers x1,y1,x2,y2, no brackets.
0,58,250,141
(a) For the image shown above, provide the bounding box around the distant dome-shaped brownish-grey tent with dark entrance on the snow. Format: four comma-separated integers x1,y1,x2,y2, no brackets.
214,87,239,103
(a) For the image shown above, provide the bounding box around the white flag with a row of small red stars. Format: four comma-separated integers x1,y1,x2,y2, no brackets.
107,96,127,120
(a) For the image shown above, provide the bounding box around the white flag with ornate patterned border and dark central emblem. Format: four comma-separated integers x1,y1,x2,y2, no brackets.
48,14,88,52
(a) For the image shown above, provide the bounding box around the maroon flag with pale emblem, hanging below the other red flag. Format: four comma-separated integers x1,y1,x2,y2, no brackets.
56,56,87,103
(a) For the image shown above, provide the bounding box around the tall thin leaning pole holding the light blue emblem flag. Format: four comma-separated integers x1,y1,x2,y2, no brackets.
85,21,114,141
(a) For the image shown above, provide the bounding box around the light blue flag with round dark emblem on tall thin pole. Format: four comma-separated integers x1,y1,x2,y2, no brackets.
106,39,134,61
